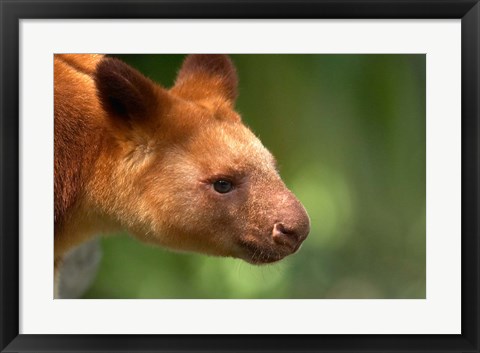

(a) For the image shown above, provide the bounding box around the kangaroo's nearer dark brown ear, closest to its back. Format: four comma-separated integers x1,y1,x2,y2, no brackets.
94,57,166,121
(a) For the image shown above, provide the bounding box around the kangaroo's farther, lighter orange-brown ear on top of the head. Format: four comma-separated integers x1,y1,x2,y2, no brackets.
172,54,238,102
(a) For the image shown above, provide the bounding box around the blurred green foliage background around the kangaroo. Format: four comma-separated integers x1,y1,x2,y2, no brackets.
85,54,426,299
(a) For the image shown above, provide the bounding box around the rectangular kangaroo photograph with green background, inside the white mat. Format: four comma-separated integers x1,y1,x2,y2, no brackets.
52,53,426,299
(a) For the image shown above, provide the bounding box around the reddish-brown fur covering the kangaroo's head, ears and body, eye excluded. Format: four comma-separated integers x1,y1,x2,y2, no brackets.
54,55,309,276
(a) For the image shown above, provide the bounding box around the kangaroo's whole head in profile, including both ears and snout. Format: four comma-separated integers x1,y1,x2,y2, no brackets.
92,55,310,264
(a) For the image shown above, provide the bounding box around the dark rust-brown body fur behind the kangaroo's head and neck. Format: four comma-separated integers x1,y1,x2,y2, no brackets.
54,55,103,234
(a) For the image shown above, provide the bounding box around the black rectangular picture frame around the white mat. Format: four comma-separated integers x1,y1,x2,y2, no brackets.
0,0,480,352
